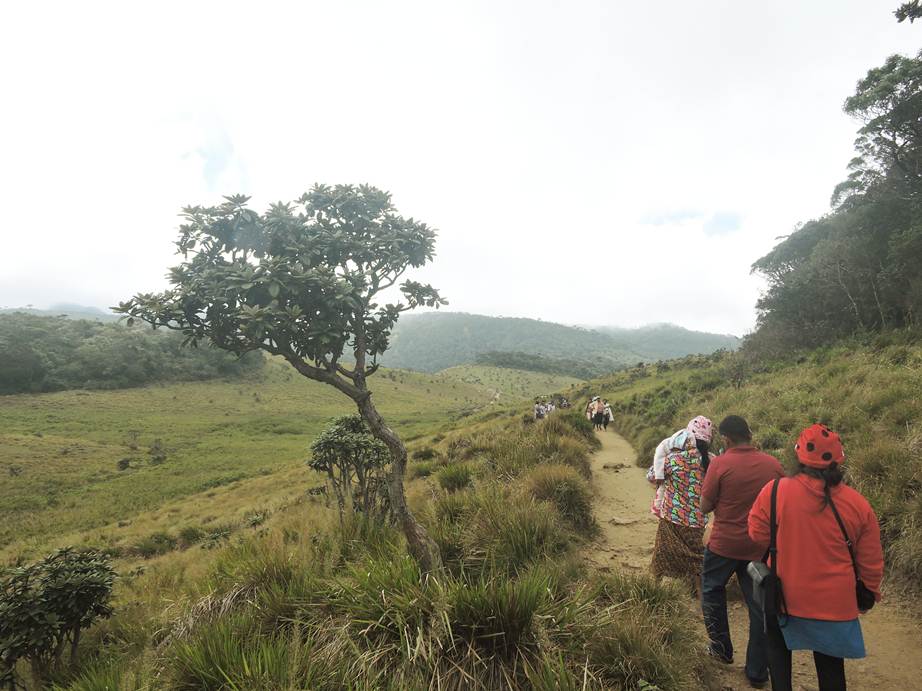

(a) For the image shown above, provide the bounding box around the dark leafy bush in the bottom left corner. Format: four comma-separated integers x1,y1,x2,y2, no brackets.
0,548,115,679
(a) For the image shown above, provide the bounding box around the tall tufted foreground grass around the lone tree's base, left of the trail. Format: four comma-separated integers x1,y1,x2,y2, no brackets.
36,409,708,691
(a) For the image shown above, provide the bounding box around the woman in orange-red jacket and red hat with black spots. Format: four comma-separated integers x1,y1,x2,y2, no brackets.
749,425,884,691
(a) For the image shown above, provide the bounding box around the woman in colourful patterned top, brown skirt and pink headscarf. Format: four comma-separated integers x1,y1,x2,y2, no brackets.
651,416,712,593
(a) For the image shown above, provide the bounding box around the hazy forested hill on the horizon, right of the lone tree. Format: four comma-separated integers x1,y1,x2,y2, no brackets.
384,312,739,374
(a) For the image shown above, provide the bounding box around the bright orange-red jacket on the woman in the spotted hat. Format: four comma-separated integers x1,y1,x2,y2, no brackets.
749,475,884,621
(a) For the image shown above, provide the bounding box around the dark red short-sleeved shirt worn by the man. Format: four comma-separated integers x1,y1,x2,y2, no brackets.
701,446,784,561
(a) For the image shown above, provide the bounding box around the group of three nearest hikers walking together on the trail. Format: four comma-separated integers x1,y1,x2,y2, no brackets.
644,414,884,691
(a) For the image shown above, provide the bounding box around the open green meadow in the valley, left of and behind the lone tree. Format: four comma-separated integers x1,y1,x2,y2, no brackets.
0,362,493,561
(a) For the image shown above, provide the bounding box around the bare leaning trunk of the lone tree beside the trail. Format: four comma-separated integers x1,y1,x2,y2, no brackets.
356,391,442,575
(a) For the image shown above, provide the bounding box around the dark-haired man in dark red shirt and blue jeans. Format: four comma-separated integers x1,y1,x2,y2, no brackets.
701,415,784,688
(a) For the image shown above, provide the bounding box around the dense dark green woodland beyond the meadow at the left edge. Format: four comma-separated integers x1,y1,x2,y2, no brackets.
0,312,263,394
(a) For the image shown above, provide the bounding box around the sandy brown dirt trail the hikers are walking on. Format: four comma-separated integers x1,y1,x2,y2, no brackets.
589,432,922,691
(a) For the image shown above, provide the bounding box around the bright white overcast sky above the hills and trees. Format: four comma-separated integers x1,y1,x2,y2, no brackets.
0,0,922,334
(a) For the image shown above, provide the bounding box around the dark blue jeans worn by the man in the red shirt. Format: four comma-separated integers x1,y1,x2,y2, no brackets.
701,548,768,682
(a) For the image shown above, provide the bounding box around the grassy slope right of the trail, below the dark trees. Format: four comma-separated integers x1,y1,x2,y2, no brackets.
583,333,922,582
